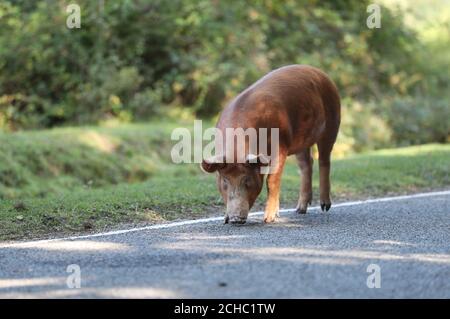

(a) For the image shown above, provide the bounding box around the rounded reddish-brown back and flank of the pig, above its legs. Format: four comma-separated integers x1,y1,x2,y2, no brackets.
217,65,340,149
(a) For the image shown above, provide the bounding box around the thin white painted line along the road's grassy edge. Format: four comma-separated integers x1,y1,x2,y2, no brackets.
0,190,450,248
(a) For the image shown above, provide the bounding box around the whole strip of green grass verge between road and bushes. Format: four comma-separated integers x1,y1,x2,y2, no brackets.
0,122,450,240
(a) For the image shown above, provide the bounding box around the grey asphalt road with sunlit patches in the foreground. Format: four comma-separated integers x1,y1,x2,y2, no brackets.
0,192,450,298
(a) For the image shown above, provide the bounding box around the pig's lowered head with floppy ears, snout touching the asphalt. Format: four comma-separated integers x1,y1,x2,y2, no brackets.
202,155,268,224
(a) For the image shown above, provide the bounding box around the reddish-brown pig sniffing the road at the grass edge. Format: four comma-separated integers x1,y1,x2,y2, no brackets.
201,65,340,224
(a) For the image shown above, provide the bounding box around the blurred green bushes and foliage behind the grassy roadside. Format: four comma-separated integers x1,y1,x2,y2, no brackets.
0,0,450,153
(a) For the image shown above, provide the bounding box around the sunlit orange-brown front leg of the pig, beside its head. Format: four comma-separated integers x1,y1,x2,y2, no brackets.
264,152,286,223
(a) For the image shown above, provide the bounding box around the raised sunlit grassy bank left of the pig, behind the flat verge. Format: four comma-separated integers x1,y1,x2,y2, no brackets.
0,123,194,199
